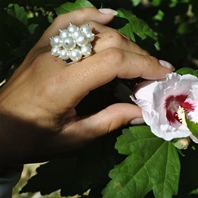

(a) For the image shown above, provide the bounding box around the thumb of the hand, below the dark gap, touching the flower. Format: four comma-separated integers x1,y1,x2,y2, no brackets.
62,103,142,141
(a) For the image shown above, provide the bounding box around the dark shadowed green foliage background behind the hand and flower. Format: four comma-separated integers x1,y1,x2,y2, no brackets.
0,0,198,198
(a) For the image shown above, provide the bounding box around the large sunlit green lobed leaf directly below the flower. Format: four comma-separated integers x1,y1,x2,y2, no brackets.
102,126,180,198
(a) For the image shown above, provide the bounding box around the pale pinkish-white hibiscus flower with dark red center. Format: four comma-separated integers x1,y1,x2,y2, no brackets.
131,73,198,143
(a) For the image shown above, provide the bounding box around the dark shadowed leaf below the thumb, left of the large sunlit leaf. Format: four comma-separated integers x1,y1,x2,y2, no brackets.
21,131,123,197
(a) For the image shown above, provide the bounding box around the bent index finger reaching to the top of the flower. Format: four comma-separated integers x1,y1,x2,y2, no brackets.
65,48,172,103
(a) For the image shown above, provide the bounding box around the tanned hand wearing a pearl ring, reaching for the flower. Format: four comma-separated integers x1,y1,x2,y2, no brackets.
0,8,172,164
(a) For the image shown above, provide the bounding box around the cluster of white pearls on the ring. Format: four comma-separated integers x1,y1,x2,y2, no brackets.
50,23,95,63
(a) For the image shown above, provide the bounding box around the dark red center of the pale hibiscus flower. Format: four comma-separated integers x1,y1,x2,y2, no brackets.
165,94,194,124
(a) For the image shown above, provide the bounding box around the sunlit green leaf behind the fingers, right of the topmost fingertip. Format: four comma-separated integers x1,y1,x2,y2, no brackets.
118,9,157,42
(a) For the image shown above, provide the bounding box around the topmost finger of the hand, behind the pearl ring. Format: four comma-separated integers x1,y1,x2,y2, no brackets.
36,8,114,47
